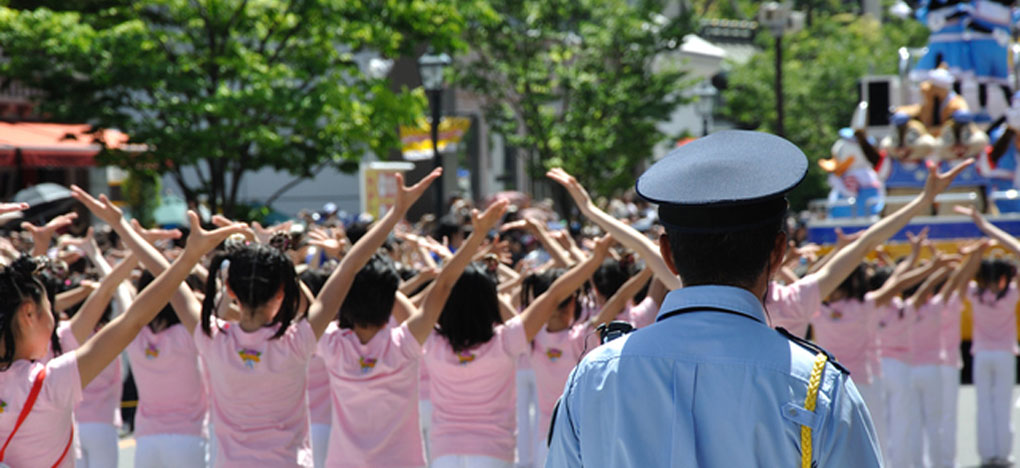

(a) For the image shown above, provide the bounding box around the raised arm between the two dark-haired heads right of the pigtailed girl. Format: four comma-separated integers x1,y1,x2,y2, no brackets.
407,200,509,344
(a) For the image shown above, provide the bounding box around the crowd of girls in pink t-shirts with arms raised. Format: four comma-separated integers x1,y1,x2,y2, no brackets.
0,158,1020,467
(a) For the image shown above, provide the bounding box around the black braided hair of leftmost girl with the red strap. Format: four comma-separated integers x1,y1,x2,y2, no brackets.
0,255,49,371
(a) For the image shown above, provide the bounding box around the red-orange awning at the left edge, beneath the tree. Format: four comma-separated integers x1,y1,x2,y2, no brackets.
0,122,128,167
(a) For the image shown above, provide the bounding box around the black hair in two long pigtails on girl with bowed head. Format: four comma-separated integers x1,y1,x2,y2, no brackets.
202,236,300,340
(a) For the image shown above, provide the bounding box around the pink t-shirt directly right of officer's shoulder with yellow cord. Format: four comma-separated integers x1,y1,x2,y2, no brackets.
811,294,877,383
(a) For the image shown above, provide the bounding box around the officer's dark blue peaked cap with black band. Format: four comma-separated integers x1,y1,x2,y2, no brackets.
636,131,808,232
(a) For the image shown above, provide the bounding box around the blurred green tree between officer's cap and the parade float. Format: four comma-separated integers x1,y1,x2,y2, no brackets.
720,14,927,209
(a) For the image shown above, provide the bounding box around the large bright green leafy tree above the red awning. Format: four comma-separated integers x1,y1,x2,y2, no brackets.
0,0,463,217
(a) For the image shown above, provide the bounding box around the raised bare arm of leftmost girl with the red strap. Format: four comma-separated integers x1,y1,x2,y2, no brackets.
75,211,248,388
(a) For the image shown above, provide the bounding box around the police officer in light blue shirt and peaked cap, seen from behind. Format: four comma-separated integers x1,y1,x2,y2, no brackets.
546,131,969,468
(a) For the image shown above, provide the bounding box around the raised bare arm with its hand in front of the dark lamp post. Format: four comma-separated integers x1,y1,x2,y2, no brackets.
308,168,443,337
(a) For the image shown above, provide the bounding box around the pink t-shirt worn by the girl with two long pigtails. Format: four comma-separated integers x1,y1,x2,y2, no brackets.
195,318,316,467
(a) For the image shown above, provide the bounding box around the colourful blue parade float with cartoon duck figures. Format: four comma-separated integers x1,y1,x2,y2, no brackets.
807,0,1020,245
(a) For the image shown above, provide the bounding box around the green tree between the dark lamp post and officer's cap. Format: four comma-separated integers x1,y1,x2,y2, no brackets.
456,0,693,199
